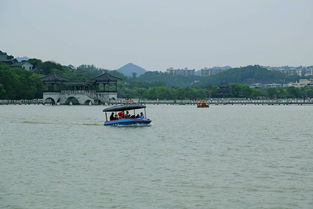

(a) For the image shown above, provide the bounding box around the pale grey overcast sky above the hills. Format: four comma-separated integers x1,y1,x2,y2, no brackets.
0,0,313,71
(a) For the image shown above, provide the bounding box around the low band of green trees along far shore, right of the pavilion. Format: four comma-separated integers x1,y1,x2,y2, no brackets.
118,83,313,100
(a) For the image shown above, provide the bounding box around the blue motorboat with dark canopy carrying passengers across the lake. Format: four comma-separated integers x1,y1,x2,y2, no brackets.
103,104,151,126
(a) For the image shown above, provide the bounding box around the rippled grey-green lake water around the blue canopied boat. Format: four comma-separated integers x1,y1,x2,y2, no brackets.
0,105,313,209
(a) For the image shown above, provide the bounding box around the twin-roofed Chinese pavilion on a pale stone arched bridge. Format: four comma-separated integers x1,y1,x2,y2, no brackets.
40,72,121,104
